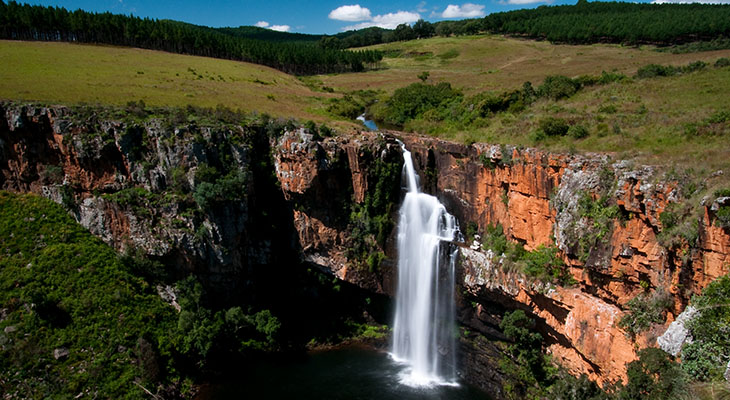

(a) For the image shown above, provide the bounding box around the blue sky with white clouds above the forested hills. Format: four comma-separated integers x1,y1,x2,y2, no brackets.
25,0,730,34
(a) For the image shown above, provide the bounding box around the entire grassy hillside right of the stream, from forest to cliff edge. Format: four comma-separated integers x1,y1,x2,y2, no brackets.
318,36,730,184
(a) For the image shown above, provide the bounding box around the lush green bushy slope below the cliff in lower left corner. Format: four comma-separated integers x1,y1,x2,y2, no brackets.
0,192,182,398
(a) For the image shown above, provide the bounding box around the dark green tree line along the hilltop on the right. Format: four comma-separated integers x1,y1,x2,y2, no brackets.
320,0,730,48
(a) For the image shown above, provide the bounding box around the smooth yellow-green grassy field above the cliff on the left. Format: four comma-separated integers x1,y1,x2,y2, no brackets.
0,41,332,119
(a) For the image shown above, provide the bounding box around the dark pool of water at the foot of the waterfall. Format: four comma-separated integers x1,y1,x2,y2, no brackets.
200,347,488,400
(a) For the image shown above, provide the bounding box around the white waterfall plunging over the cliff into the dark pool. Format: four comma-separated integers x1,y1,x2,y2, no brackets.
392,143,458,386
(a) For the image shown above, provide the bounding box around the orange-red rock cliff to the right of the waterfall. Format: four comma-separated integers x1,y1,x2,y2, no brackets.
401,135,730,382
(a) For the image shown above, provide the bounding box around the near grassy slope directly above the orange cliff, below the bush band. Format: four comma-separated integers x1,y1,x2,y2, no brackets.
458,68,730,180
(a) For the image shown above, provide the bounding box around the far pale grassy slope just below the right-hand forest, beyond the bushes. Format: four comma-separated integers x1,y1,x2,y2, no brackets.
319,35,730,94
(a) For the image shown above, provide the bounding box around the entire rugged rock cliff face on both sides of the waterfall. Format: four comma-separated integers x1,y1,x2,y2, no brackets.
0,105,730,398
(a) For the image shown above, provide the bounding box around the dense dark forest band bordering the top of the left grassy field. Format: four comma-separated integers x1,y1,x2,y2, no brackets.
0,0,382,75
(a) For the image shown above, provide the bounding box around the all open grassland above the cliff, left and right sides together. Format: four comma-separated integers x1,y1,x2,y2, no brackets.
0,35,730,179
